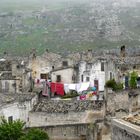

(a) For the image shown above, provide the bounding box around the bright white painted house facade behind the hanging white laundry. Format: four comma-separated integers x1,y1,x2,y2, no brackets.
79,60,105,91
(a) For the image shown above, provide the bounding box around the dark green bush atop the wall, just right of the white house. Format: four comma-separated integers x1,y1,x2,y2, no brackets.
105,79,123,91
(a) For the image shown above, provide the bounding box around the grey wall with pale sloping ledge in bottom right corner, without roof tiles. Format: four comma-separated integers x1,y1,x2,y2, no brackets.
111,120,140,140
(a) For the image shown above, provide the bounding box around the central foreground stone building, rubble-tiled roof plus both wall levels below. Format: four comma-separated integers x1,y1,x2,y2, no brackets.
29,100,103,140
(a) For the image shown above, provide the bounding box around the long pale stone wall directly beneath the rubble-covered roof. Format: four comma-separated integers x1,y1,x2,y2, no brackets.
29,111,103,127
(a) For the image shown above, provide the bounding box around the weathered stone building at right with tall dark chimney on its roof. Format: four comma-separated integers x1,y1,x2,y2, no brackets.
105,46,140,88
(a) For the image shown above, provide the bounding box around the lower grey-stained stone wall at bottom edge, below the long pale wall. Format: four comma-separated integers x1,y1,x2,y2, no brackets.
38,124,91,140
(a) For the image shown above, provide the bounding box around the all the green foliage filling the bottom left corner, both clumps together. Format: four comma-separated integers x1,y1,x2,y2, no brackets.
0,118,49,140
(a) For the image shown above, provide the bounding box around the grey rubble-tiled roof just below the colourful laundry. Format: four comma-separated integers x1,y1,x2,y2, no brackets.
33,99,101,113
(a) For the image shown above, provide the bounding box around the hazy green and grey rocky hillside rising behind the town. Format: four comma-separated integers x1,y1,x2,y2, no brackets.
0,0,140,55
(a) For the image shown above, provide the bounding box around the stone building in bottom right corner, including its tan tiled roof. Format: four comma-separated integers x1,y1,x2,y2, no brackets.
111,114,140,140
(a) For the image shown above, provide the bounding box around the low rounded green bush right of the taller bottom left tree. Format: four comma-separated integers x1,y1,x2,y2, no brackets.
19,128,49,140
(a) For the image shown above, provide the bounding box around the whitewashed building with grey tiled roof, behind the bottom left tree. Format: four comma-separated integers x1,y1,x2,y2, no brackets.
0,93,38,126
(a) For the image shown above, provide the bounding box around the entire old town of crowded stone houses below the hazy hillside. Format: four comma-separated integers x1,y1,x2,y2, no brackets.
0,45,140,140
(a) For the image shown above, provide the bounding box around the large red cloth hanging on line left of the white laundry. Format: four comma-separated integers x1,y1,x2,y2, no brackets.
51,83,64,96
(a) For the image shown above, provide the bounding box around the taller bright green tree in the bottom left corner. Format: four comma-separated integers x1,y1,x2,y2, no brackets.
0,118,24,140
